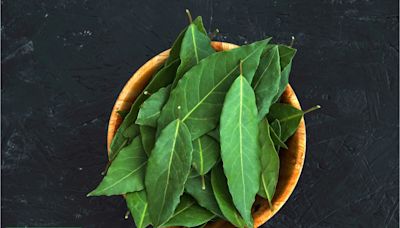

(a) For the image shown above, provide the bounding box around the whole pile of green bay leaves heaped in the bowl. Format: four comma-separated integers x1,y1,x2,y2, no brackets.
88,13,318,227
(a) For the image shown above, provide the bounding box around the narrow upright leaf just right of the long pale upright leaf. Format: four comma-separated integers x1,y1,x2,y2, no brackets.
258,120,279,208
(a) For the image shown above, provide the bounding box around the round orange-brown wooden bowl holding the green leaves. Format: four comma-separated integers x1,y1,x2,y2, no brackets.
107,42,306,228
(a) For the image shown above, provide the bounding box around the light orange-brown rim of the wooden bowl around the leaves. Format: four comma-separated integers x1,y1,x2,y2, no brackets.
107,41,306,227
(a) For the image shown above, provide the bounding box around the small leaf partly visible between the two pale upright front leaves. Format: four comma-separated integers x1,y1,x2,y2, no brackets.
192,135,220,175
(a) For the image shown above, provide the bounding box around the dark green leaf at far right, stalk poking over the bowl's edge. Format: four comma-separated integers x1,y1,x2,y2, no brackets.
268,103,304,142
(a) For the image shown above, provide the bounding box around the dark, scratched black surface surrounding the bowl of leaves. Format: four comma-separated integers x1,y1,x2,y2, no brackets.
1,0,399,228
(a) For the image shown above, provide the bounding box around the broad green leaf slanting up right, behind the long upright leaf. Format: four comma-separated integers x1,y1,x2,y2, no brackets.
158,39,269,140
